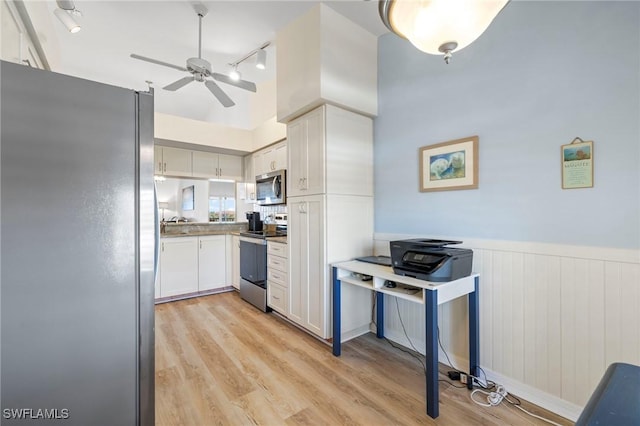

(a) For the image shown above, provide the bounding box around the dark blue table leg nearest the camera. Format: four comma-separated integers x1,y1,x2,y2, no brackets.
425,290,440,419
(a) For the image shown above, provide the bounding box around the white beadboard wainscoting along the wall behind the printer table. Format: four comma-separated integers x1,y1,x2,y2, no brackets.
375,234,640,421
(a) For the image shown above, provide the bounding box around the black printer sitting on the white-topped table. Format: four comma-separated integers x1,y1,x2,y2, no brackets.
390,238,473,282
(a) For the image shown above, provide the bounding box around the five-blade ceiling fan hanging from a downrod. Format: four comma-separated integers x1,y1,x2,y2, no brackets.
130,2,256,107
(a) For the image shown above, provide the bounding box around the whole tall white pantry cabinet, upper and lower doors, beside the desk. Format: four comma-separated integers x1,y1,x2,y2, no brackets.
287,105,373,339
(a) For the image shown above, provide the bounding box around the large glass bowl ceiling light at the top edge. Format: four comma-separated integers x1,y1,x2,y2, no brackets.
378,0,509,64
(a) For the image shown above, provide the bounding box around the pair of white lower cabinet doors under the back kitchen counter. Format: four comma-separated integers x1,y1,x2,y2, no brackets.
155,235,227,298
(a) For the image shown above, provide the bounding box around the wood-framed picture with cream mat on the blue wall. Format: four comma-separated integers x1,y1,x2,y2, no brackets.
419,136,479,192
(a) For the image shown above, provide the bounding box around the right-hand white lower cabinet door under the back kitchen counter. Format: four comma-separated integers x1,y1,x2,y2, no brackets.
198,235,227,291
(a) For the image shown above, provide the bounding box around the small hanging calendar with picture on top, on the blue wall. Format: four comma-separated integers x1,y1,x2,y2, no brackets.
560,138,594,189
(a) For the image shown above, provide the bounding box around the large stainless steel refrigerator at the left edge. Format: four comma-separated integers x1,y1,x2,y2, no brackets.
0,62,157,425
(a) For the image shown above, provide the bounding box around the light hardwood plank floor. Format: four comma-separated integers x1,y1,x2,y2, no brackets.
156,292,572,426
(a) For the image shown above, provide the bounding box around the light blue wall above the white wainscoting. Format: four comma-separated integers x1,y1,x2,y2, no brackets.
374,1,640,249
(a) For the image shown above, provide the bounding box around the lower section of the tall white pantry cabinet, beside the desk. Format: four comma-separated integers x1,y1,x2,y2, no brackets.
287,195,373,339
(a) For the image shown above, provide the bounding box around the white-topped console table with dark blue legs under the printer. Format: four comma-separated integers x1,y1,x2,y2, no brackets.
332,260,480,419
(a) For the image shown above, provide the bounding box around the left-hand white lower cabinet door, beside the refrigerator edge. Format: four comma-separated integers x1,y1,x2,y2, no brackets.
160,237,198,297
